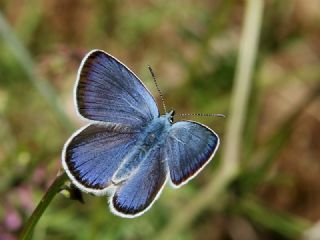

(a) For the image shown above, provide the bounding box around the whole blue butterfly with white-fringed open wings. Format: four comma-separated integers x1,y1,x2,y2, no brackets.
62,50,219,218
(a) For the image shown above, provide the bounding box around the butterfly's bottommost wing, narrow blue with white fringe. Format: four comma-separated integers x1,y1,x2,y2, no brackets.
110,147,167,217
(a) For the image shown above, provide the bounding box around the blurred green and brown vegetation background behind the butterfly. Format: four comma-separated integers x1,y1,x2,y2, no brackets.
0,0,320,240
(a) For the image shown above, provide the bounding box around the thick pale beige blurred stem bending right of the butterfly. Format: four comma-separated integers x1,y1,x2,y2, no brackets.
156,0,264,240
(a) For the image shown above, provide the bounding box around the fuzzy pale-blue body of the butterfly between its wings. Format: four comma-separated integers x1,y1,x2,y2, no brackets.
112,114,172,184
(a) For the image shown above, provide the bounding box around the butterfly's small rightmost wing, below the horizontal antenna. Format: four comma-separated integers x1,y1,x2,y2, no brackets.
164,121,219,187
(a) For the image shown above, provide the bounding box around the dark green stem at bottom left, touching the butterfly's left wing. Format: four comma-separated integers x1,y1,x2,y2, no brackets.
20,173,67,240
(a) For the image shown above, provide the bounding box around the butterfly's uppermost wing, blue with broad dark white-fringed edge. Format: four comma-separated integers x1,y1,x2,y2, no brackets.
75,50,159,127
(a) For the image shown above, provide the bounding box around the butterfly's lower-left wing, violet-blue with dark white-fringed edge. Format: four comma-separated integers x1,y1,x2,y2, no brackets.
62,124,139,195
